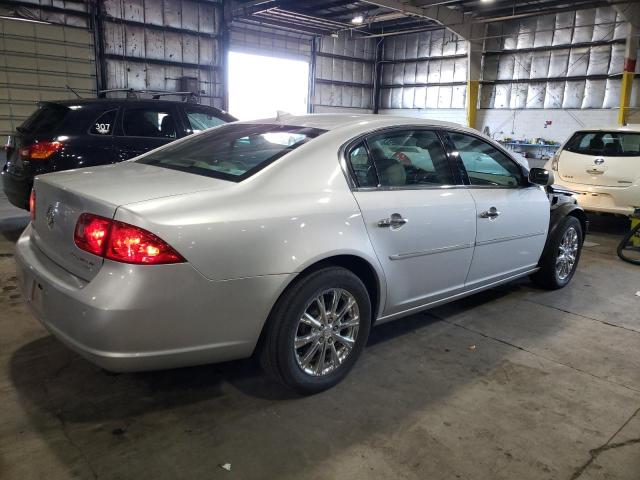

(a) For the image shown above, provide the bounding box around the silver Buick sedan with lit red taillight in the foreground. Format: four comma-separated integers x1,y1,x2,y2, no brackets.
16,115,586,393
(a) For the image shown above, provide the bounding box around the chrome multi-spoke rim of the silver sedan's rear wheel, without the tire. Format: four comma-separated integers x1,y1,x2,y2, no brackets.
293,288,360,376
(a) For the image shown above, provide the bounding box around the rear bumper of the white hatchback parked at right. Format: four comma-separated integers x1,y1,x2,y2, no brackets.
556,178,640,216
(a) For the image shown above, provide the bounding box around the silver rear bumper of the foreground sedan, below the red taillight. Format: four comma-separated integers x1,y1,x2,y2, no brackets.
15,226,296,372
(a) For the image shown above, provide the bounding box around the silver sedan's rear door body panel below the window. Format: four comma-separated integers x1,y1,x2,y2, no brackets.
354,188,476,315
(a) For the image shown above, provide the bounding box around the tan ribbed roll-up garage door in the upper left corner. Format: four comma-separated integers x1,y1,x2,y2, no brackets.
0,0,96,135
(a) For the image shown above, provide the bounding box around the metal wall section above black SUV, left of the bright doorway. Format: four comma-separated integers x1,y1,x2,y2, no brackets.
100,0,224,107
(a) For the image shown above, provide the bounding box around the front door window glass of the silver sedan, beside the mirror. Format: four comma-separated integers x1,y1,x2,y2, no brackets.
449,132,522,187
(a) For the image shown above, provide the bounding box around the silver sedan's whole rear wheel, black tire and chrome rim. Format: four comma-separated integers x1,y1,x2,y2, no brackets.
260,267,371,395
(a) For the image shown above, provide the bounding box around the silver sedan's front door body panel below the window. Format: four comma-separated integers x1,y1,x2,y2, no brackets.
467,187,550,288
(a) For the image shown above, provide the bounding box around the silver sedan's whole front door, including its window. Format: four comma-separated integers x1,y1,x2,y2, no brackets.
448,132,550,289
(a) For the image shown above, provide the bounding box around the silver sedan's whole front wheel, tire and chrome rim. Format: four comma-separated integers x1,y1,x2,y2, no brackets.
531,216,583,290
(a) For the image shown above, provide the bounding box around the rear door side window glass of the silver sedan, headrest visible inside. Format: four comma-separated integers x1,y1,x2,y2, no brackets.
351,130,453,187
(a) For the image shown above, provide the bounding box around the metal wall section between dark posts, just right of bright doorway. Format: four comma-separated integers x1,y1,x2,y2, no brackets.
312,35,376,111
